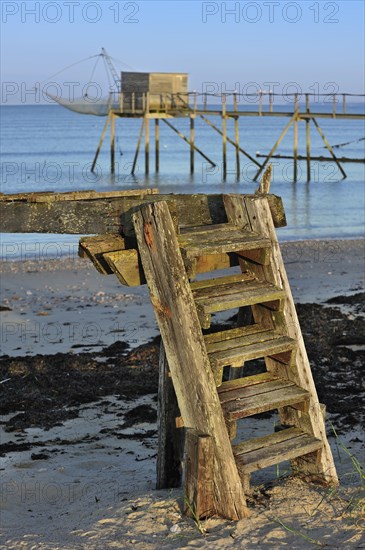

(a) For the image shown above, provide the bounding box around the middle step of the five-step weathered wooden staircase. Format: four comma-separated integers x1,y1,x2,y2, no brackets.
206,327,296,369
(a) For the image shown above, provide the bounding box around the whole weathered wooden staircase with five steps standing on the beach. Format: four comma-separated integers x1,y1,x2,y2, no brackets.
81,194,338,520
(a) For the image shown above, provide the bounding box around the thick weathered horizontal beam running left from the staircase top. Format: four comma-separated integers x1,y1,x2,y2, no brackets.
0,190,284,236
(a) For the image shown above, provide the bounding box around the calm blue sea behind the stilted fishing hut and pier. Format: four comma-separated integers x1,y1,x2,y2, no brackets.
0,104,365,260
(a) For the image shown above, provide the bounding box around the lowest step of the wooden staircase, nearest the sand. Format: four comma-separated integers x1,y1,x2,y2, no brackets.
233,428,323,474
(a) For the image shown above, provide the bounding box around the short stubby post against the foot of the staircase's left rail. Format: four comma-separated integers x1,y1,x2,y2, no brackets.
184,429,216,519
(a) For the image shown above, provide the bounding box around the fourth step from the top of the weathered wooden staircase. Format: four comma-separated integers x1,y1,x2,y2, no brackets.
222,386,308,420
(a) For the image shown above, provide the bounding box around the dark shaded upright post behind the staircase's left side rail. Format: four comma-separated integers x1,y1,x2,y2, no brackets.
156,342,185,489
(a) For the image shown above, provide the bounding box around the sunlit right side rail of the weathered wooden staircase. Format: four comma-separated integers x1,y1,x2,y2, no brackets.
244,197,338,485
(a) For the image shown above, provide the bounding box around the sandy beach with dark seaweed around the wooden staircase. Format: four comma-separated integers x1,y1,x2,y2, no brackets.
0,239,365,549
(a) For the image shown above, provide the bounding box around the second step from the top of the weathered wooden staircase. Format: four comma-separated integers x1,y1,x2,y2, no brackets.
191,274,285,328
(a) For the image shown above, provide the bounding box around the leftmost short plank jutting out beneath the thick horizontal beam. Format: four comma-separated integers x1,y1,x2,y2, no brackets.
79,234,125,275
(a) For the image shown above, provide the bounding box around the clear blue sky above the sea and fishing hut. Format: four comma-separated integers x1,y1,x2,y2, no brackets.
1,0,365,103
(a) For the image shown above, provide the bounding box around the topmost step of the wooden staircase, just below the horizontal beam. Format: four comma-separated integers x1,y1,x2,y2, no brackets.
179,223,271,258
